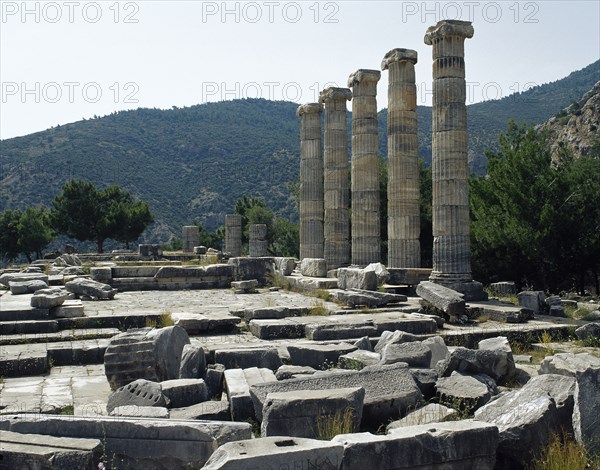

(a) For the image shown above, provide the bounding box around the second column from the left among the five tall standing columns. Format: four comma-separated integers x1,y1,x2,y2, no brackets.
319,88,352,269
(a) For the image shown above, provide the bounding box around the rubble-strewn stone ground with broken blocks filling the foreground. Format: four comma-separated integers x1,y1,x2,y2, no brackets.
0,260,600,469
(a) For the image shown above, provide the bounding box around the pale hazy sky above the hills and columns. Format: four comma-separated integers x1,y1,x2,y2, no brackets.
0,0,600,139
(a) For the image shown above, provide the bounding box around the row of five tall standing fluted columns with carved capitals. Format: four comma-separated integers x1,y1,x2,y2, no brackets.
297,20,484,300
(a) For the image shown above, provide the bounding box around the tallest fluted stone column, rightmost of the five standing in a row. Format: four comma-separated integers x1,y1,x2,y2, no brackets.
425,20,473,285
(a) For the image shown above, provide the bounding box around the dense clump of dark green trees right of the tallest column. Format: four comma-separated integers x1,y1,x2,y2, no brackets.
470,121,600,291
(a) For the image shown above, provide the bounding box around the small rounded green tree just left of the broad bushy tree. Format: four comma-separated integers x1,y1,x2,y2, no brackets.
18,206,54,263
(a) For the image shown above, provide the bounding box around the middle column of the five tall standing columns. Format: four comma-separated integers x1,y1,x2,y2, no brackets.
348,69,381,266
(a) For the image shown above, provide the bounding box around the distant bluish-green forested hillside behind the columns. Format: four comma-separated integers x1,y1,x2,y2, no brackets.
0,61,600,241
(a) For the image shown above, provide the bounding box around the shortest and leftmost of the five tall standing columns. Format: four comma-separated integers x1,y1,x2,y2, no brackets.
296,103,323,259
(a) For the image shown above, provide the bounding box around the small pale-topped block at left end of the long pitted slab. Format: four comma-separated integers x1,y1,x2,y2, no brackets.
225,367,277,421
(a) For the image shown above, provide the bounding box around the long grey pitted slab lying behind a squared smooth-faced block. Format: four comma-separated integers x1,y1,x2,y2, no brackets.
250,364,422,426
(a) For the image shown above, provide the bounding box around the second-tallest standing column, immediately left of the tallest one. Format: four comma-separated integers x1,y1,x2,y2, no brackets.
381,49,421,268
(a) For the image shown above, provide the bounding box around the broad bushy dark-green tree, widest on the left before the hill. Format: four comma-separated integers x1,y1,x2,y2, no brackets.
51,180,153,253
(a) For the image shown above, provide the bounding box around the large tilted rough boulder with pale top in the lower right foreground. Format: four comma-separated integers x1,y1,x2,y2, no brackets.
475,375,574,469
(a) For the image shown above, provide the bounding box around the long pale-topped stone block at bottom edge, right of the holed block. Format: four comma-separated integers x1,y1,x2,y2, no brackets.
331,420,498,470
